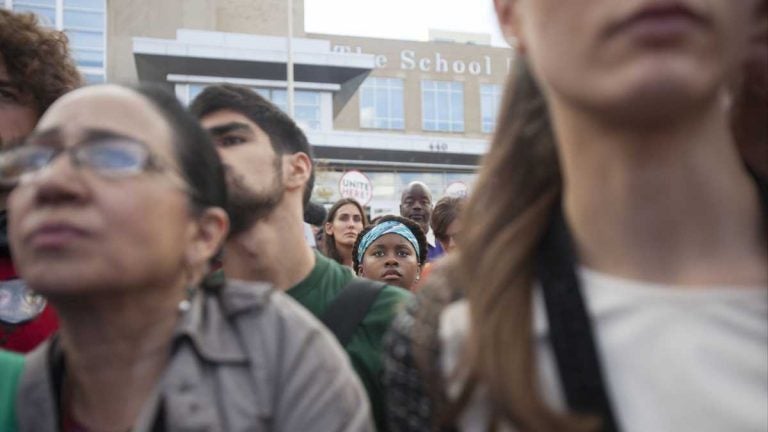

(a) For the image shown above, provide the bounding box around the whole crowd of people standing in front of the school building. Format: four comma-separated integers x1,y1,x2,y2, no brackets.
0,0,768,432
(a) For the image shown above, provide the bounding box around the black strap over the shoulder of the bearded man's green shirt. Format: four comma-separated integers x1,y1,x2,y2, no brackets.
320,277,386,347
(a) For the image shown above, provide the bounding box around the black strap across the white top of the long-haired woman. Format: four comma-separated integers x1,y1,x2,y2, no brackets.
536,208,618,432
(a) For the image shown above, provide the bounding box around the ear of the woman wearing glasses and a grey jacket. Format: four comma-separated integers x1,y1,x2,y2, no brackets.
185,207,229,268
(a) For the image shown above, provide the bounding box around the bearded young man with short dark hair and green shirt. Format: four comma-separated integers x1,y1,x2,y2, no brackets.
190,84,409,431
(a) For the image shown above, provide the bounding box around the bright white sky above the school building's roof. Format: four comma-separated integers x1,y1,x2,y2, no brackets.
304,0,506,46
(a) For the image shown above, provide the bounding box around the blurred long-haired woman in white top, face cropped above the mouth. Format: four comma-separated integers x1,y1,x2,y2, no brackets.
386,0,768,432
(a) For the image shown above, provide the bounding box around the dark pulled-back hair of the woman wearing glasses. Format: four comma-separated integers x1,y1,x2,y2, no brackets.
133,85,227,211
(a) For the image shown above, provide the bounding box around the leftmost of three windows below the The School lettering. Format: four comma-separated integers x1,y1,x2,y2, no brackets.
360,77,405,129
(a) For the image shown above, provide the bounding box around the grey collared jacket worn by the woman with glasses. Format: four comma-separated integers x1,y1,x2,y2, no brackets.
16,281,373,432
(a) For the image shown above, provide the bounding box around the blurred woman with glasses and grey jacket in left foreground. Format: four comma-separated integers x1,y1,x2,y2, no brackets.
5,86,371,431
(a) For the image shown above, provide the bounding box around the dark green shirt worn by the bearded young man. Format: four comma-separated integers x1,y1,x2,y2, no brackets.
287,253,411,431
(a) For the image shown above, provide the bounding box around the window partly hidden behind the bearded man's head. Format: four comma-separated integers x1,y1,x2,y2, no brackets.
181,84,322,130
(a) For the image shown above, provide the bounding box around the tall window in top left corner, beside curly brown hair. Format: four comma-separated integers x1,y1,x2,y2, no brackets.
6,0,106,84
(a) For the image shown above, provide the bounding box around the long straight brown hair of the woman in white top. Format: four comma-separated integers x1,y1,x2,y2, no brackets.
411,58,596,431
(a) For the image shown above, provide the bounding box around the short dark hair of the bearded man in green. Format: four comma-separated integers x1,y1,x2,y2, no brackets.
189,84,315,207
